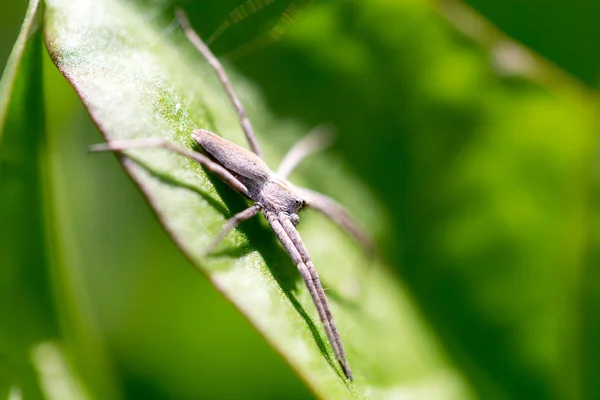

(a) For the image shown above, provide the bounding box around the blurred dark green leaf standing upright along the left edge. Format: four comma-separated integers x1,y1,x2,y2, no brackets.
0,1,123,399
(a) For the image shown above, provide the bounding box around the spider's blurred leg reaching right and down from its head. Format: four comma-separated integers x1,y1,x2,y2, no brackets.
296,187,375,253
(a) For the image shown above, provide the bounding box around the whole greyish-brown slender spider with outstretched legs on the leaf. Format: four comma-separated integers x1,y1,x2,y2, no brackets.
91,10,372,381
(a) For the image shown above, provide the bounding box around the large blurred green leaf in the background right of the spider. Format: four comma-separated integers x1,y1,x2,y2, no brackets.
219,0,600,399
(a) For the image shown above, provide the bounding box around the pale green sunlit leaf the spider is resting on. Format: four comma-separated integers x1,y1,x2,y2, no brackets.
45,0,470,398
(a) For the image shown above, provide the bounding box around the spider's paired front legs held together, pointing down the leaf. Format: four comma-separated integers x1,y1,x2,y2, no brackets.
265,213,352,380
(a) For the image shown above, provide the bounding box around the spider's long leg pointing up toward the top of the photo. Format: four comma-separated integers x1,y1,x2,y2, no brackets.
175,9,263,158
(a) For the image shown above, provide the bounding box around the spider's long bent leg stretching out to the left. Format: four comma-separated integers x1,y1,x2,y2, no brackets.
90,138,250,197
